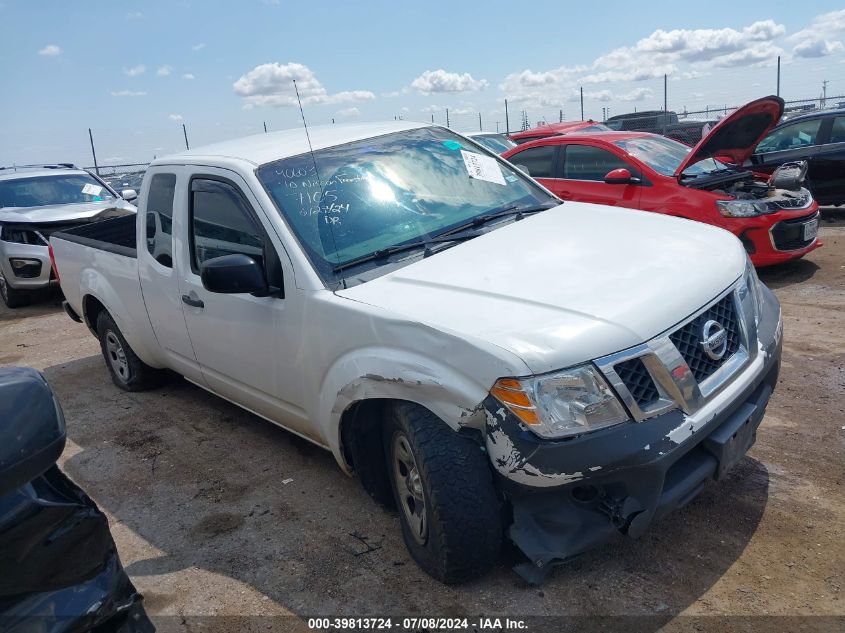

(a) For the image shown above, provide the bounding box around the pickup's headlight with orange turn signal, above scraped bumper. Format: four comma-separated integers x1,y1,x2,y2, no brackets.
490,364,630,438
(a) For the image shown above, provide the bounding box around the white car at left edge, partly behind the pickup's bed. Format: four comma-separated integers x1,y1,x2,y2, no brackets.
0,164,137,308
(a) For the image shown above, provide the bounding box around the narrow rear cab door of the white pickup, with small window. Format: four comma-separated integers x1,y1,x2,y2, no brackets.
137,167,203,382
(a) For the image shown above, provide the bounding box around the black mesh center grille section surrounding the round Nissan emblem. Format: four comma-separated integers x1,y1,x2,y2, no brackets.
669,293,739,383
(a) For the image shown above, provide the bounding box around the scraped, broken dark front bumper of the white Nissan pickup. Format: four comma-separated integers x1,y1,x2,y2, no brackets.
484,290,783,582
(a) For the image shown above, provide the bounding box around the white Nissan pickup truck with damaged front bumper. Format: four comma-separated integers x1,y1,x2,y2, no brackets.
51,122,782,582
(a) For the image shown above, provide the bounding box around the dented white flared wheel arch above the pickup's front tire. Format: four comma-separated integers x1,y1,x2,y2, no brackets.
317,347,491,472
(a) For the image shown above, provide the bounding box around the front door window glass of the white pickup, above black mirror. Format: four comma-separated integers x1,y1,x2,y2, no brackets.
191,178,264,272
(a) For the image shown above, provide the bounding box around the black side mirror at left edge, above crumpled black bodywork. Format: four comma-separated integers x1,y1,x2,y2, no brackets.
0,367,67,497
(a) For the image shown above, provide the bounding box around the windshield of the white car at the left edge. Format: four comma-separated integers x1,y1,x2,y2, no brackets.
0,174,115,207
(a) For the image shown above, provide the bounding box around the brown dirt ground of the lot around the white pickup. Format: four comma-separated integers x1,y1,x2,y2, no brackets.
0,209,845,630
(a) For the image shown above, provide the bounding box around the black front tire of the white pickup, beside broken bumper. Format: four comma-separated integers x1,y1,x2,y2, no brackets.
384,403,503,584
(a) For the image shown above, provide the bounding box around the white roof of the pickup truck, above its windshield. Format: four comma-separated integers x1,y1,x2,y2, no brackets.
150,121,433,167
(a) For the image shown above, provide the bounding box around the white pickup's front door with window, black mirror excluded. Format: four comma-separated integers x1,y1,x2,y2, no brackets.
180,167,312,441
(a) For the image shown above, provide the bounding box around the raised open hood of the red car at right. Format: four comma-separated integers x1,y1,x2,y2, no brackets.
675,96,783,177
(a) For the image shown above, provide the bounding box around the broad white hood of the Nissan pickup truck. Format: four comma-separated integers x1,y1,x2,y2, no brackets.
338,202,746,373
